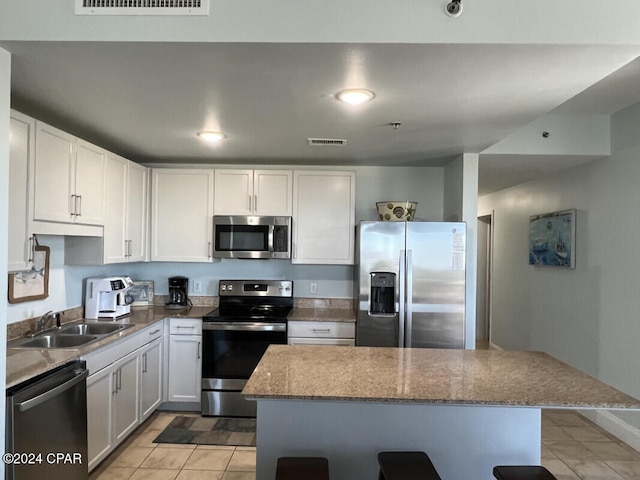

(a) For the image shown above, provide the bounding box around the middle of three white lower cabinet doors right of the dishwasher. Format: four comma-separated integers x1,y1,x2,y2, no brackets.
113,353,140,445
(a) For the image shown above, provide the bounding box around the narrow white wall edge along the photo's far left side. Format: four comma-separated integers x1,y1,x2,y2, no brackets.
0,48,11,478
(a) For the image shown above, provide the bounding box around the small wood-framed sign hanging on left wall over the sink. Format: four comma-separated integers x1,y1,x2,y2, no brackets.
9,245,51,303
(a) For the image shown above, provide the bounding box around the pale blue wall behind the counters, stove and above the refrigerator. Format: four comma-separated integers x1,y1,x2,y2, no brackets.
7,165,444,323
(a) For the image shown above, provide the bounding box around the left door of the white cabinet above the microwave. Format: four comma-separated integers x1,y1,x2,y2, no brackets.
213,170,254,215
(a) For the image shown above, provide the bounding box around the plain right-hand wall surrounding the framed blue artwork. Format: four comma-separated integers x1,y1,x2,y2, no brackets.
479,105,640,446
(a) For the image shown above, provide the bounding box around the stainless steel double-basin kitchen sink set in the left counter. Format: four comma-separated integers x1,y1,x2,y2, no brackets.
7,322,135,348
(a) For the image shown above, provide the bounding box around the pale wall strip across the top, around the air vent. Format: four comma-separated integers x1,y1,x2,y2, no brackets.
0,0,640,45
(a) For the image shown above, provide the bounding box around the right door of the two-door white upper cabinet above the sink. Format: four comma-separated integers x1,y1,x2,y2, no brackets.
75,140,107,225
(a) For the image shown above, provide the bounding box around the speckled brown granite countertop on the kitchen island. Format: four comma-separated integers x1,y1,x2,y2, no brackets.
242,345,640,409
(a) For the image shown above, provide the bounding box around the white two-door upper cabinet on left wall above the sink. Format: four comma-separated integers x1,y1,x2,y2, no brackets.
33,121,106,225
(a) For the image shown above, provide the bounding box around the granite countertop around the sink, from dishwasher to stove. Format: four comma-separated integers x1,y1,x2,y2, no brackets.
6,306,212,388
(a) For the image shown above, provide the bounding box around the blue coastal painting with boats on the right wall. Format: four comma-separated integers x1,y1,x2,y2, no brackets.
529,209,576,268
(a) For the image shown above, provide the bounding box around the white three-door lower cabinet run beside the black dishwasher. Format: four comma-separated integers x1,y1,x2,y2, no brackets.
84,323,163,471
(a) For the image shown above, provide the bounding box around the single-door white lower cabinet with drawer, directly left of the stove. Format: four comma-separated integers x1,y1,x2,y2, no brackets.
167,318,202,403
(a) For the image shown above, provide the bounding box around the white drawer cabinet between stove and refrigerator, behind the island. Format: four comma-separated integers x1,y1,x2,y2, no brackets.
287,321,356,347
